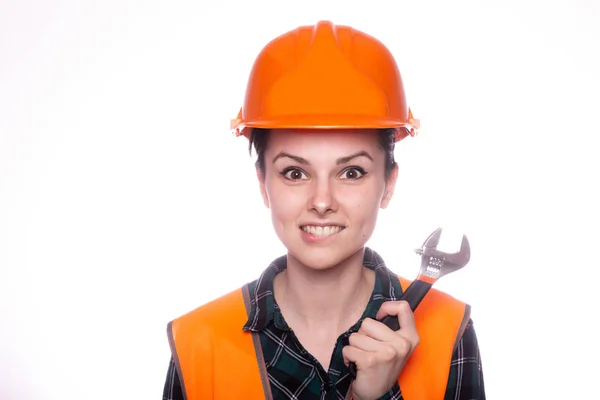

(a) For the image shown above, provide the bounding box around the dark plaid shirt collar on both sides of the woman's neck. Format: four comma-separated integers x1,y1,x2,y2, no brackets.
243,247,402,332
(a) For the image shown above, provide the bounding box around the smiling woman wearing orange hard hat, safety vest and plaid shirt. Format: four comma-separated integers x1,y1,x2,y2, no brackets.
163,21,485,400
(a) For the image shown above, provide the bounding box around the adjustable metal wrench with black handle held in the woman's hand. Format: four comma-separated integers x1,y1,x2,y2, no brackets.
350,228,471,379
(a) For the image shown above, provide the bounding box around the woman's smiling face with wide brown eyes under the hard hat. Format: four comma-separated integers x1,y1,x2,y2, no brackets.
260,130,397,269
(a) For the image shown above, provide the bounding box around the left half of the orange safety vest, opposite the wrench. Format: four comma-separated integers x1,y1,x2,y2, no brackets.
167,285,272,400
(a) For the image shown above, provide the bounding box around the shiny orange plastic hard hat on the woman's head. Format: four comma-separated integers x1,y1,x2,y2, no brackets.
231,21,419,141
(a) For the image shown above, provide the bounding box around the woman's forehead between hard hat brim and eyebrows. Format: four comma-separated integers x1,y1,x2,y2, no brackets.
267,129,379,156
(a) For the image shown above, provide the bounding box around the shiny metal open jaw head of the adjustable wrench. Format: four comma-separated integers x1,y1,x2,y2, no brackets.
415,228,471,284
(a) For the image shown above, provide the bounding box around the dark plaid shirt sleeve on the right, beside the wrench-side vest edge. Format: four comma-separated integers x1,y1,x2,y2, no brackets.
444,320,485,400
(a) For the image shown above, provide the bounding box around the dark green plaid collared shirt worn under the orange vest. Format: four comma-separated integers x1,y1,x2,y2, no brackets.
163,248,485,400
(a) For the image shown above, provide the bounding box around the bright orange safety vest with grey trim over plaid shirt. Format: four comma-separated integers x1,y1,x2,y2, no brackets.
167,277,470,400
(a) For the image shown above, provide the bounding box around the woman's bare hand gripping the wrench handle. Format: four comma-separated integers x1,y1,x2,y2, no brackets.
342,301,419,400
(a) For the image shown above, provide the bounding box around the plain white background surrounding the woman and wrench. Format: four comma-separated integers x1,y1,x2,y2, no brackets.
0,0,600,400
